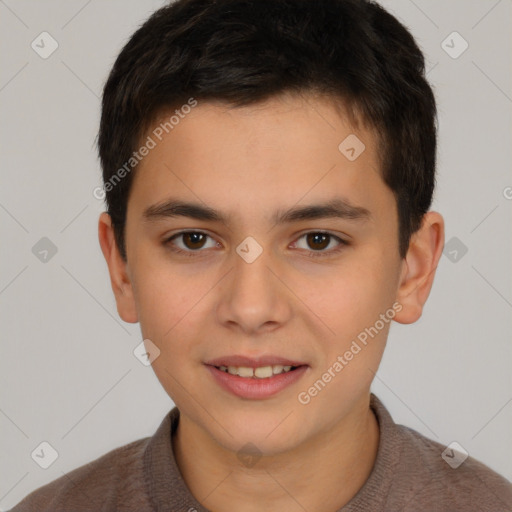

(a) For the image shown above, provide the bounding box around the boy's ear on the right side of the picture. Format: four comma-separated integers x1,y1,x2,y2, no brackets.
394,211,444,324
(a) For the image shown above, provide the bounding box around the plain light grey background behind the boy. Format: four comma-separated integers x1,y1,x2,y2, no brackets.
0,0,512,510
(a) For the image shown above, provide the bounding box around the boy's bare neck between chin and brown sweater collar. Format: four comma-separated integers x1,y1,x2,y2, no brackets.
173,397,379,512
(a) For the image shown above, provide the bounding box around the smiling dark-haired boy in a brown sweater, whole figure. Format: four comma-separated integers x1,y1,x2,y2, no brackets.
14,0,512,512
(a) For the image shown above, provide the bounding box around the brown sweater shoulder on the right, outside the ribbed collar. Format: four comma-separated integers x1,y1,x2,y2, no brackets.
397,425,512,512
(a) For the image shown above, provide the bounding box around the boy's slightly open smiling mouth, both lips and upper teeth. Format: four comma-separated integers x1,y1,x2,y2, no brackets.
205,356,309,400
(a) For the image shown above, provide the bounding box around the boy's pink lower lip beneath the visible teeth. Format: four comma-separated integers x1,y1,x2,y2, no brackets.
206,365,308,400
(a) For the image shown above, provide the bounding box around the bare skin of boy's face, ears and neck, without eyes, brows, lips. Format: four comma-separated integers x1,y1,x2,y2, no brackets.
99,95,444,512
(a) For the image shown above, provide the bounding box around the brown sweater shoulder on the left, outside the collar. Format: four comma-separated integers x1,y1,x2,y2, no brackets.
12,438,151,512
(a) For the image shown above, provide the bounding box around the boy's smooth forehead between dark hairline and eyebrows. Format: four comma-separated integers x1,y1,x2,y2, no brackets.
127,95,390,224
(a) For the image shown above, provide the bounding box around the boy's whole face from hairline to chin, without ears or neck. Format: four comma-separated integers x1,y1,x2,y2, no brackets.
120,96,402,454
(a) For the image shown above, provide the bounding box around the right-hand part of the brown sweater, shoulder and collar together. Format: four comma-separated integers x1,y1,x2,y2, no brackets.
360,394,512,512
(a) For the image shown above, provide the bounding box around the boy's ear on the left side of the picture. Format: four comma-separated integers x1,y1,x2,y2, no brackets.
98,212,138,323
